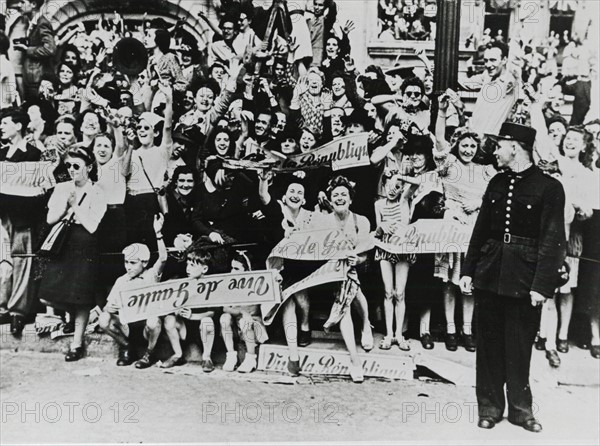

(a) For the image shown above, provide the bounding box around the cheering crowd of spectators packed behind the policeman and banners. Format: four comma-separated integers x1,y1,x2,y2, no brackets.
0,0,600,382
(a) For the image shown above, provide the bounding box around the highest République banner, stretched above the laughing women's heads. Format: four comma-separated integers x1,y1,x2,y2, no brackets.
281,133,370,170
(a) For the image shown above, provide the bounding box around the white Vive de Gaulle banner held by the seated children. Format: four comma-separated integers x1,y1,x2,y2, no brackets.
120,270,281,323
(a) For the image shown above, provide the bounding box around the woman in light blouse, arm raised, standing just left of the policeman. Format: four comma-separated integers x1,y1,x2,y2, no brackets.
434,93,496,352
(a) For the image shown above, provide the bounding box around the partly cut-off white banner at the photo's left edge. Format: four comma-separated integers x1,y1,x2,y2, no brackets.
0,161,56,197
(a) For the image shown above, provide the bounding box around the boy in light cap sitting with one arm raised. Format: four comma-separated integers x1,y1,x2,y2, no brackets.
99,215,167,369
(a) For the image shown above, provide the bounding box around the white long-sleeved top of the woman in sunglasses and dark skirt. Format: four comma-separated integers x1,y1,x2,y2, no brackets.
48,181,106,234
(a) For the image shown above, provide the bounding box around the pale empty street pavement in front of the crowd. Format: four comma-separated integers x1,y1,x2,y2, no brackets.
0,328,600,445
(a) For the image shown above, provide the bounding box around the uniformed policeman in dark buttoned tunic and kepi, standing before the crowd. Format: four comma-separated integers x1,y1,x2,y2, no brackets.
461,122,566,432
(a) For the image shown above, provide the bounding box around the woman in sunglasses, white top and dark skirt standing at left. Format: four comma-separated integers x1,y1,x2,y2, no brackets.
40,148,106,362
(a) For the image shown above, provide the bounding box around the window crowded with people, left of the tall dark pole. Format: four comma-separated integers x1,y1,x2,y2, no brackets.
377,0,437,41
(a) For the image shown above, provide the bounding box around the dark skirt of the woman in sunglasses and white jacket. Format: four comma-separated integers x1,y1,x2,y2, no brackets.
39,224,99,311
